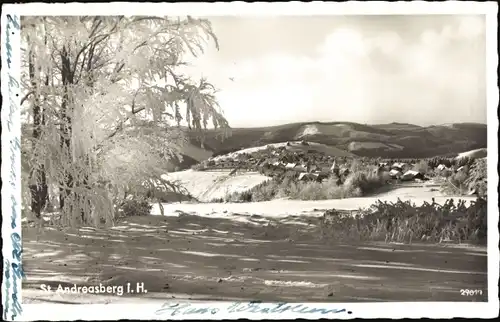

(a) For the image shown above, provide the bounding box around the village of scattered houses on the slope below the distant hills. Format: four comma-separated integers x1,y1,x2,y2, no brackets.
192,140,484,195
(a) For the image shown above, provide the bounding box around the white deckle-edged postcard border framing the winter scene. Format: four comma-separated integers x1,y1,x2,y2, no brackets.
1,1,499,320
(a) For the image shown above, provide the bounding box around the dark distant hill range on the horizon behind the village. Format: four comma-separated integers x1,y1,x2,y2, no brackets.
183,122,487,164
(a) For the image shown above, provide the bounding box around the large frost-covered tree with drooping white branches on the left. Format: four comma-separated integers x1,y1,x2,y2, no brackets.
21,16,228,225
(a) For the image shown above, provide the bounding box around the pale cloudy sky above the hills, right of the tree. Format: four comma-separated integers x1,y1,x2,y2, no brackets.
184,15,486,127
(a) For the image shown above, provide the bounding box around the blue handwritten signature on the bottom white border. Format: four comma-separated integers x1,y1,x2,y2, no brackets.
155,302,351,316
